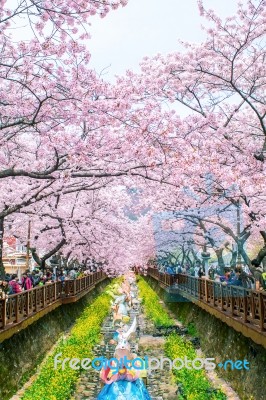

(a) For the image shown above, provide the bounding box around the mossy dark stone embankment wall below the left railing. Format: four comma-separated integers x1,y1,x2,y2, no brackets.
0,280,109,400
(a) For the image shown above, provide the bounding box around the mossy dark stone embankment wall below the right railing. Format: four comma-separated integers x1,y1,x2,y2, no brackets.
146,278,266,400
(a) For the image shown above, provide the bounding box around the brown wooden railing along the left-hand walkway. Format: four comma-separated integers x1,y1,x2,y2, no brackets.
0,271,106,333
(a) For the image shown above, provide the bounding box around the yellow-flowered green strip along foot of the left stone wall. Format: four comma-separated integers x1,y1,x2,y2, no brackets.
22,284,110,400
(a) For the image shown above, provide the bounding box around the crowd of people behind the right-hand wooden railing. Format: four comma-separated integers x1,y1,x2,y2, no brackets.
158,261,266,290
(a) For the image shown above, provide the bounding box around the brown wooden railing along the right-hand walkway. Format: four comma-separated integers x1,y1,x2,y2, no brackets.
147,267,266,332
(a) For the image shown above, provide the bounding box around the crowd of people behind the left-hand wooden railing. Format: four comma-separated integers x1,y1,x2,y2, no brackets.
0,266,101,299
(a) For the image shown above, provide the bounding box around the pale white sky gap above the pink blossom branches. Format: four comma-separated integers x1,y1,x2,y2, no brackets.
88,0,237,80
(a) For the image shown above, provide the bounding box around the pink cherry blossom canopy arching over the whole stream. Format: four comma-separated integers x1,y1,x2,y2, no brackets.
0,0,266,273
